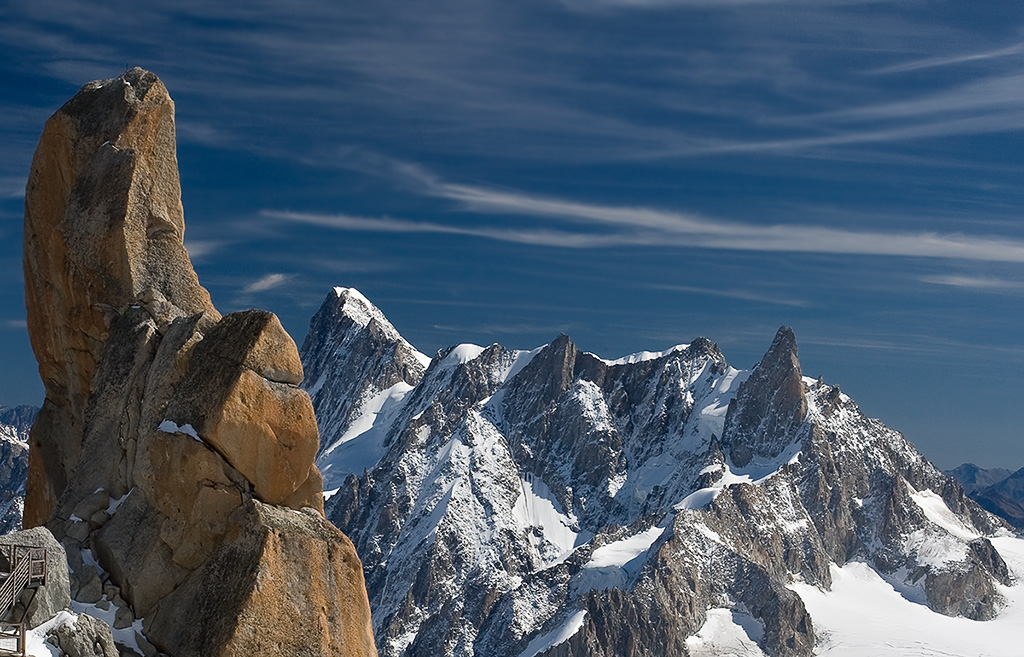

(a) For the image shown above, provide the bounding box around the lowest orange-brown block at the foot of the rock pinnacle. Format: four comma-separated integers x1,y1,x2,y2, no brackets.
146,500,376,657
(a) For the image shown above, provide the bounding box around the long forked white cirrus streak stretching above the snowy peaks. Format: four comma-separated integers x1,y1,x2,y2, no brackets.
261,172,1024,263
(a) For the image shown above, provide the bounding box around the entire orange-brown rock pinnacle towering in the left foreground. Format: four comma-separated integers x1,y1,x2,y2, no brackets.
25,69,375,657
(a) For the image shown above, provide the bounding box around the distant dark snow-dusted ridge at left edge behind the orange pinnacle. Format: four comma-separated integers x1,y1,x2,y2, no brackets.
0,405,39,534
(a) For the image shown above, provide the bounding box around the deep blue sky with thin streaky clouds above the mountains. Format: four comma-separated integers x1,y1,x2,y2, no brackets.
0,0,1024,469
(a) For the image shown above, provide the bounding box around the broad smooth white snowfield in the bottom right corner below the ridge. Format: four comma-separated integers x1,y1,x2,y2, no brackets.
790,536,1024,657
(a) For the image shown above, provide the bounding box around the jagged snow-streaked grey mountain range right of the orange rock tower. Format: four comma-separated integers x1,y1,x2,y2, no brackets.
302,288,1010,657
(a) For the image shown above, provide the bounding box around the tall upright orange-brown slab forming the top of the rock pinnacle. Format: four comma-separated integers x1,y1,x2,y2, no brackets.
25,69,217,526
